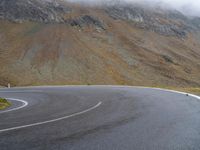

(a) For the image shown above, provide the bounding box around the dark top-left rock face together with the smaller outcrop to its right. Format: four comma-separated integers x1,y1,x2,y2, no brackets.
0,0,105,29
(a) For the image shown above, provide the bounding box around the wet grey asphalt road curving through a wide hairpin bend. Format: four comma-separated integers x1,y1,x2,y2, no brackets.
0,86,200,150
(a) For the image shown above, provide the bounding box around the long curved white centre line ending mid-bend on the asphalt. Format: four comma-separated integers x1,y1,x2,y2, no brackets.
0,102,102,133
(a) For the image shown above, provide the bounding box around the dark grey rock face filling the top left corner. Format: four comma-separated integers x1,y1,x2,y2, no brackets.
0,0,70,22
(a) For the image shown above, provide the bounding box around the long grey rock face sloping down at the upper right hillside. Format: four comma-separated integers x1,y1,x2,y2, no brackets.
106,5,188,38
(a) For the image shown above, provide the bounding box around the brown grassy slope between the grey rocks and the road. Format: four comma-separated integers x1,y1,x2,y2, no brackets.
0,6,200,90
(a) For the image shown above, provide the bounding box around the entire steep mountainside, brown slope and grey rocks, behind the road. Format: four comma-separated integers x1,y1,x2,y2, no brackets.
0,0,200,87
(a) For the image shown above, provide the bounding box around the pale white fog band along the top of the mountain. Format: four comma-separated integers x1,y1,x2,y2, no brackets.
65,0,200,16
